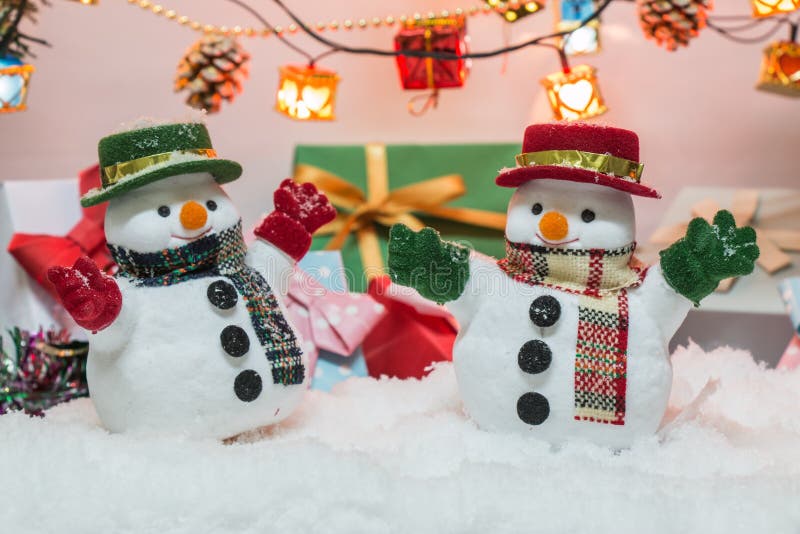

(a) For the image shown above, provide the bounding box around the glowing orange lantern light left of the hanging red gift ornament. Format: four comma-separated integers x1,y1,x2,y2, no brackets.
275,65,339,121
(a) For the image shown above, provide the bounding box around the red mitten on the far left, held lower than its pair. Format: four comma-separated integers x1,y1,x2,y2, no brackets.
47,256,122,333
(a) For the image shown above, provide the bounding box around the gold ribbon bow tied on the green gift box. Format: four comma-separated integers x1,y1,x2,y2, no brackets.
294,144,506,279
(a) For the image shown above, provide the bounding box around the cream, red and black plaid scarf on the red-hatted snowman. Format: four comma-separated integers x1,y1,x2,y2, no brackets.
497,241,645,425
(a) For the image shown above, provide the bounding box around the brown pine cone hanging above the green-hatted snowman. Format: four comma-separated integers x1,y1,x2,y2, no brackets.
175,34,250,113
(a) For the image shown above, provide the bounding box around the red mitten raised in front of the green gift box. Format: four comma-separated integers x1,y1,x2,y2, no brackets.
255,178,336,261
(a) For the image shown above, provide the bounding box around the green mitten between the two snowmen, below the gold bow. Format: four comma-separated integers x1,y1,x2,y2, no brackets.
388,224,469,304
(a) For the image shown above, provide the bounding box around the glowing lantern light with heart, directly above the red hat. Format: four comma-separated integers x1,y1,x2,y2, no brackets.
541,65,608,120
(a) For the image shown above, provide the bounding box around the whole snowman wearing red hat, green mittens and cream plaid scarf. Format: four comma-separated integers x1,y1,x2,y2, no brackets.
388,123,758,448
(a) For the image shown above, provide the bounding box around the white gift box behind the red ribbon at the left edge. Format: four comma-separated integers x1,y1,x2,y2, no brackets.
0,178,85,338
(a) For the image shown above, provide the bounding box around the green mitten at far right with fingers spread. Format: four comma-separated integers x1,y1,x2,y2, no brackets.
661,210,759,306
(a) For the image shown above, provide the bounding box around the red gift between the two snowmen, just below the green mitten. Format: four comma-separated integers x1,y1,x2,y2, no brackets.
362,276,458,378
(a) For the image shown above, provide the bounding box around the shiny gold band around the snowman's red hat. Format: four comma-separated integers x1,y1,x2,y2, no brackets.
516,150,644,184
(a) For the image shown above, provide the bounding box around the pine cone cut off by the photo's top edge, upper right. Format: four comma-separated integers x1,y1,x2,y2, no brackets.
636,0,712,52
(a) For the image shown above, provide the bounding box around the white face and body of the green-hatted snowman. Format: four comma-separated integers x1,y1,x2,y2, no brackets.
87,173,305,438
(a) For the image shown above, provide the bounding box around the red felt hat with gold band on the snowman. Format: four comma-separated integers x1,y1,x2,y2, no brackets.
495,122,661,198
